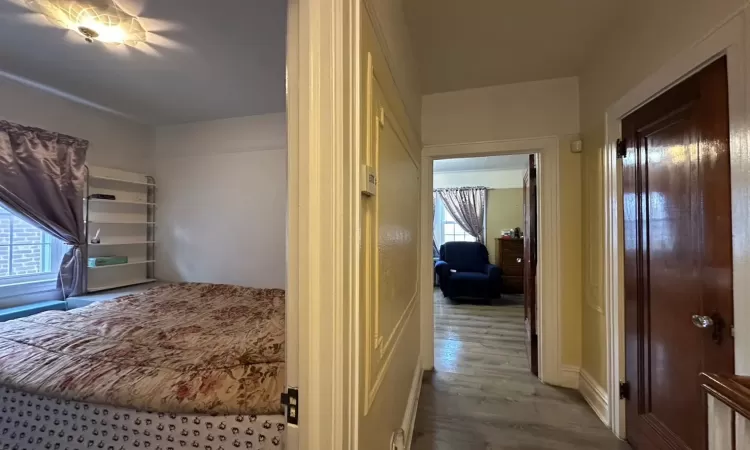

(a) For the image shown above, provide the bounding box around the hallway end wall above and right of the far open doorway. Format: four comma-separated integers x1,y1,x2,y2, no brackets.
422,77,583,372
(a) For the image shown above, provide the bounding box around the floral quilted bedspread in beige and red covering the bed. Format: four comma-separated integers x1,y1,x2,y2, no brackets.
0,283,286,414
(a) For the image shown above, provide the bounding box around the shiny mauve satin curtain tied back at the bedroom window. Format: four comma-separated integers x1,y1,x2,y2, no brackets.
0,120,89,297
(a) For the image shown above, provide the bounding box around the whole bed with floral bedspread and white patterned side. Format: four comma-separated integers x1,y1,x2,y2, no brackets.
0,283,286,450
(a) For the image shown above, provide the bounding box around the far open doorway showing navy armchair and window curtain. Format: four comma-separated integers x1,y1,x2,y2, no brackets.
432,154,539,376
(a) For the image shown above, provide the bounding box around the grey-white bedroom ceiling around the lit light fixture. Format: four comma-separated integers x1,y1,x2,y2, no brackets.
0,0,286,125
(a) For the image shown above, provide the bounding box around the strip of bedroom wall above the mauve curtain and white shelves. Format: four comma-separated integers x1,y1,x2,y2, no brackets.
0,78,151,173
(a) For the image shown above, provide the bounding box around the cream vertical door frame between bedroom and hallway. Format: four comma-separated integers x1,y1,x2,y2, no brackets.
285,0,361,450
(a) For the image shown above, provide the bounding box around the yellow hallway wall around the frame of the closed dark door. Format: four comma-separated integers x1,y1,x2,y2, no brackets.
580,0,744,387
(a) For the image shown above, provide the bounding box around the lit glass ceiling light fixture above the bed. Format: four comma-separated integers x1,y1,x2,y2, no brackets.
26,0,146,46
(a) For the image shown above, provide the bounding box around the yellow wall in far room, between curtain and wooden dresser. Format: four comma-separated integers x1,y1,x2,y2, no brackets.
487,189,523,264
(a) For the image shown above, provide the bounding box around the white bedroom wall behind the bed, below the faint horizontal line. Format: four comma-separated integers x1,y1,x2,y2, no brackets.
154,113,287,288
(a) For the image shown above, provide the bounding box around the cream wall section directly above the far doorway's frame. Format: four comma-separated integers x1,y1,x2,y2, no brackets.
422,78,579,145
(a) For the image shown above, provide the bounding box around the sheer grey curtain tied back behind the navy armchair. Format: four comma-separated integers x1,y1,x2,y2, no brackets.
436,187,487,244
